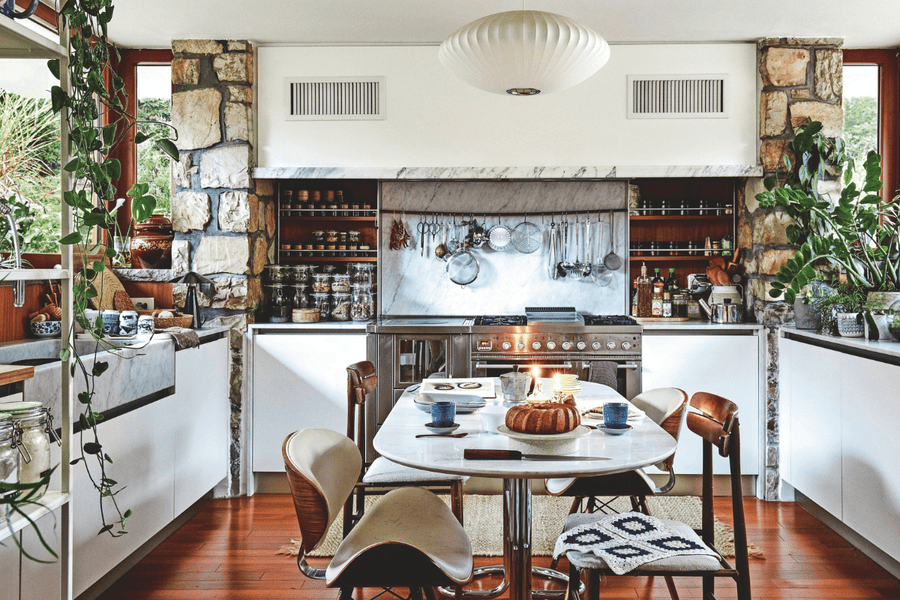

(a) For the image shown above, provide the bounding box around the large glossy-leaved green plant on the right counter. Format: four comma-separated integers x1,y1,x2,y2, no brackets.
756,121,900,303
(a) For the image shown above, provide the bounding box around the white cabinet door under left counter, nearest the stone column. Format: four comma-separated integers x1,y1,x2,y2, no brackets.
169,339,231,516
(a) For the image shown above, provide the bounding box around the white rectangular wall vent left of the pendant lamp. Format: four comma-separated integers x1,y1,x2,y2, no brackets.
285,77,384,121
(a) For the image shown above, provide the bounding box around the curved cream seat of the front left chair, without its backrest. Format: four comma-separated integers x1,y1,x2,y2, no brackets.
325,487,474,587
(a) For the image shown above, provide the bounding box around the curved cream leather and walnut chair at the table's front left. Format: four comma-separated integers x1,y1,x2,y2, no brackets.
282,429,474,600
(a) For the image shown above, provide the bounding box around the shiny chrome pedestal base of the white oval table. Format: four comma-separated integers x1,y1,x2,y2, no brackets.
440,479,584,600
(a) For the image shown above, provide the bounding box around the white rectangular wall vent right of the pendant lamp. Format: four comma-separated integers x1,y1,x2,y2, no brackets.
628,74,728,119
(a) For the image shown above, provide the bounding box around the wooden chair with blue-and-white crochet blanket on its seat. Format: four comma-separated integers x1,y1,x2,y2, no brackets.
561,392,750,600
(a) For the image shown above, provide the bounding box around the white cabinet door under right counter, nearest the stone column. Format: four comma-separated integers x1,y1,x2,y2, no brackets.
781,340,842,519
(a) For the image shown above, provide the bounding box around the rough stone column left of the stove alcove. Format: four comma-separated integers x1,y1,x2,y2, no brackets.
172,40,275,495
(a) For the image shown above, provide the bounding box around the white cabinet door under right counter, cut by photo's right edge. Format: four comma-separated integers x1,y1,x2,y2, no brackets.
831,355,900,560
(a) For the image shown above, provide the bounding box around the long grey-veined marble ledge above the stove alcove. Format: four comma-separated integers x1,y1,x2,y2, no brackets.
253,165,763,180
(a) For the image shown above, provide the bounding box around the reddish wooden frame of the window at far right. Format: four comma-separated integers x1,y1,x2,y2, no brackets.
844,48,900,202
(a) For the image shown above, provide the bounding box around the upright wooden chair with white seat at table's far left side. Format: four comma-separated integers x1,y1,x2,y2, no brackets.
344,361,468,536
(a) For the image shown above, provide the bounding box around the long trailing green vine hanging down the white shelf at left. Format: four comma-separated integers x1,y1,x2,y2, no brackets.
41,0,178,537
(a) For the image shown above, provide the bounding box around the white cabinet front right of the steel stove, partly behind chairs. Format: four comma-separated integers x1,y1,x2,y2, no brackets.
642,334,761,475
